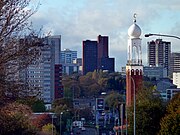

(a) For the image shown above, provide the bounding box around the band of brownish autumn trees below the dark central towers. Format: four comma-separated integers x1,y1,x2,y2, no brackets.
62,70,125,98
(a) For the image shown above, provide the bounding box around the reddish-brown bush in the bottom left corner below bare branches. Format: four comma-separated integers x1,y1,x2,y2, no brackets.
0,103,37,135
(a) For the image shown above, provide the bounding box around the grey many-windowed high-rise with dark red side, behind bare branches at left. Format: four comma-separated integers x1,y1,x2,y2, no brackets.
23,35,63,103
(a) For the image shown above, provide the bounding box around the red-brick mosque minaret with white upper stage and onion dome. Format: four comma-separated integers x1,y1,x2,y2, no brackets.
126,14,143,106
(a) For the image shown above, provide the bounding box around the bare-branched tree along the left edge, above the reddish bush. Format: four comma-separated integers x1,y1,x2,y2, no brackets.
0,0,42,105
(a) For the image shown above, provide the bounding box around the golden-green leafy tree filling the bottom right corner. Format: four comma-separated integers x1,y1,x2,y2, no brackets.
159,93,180,135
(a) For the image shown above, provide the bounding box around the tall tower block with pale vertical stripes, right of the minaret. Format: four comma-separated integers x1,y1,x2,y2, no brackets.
147,39,171,75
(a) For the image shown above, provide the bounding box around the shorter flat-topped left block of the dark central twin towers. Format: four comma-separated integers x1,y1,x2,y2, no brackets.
82,40,98,75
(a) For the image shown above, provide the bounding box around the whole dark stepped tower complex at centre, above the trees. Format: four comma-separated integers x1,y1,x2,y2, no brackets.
83,35,115,74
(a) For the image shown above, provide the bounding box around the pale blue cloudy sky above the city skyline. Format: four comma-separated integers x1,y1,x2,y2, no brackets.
30,0,180,71
